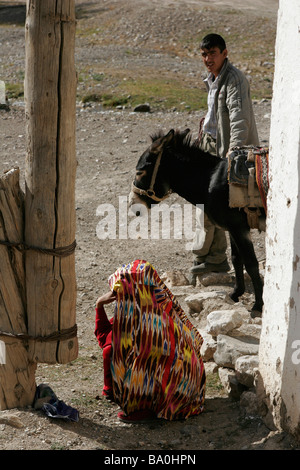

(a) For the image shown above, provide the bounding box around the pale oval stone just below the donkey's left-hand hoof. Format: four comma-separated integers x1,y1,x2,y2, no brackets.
207,310,243,336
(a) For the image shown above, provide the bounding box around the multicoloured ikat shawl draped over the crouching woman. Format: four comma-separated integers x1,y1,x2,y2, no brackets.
109,260,205,420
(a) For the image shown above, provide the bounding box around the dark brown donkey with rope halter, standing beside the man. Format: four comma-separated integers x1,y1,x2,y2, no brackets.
129,129,265,318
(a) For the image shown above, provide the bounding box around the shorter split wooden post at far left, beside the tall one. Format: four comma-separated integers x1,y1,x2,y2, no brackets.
0,169,36,410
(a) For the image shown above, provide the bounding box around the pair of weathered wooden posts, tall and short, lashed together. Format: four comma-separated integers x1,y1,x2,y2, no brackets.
0,0,78,410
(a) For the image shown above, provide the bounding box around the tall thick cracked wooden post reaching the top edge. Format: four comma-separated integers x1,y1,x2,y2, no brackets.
25,0,78,363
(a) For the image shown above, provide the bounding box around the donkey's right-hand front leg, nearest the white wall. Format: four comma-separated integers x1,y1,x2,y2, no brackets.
232,230,263,317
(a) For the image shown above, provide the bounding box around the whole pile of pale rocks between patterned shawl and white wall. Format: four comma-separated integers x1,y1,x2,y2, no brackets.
164,272,261,414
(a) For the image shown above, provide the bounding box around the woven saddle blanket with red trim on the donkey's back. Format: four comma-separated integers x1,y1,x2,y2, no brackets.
227,146,269,211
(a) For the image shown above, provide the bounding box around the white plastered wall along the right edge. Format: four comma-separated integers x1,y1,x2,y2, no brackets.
259,0,300,436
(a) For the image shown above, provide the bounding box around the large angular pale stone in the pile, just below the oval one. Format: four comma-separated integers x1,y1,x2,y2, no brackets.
214,335,259,369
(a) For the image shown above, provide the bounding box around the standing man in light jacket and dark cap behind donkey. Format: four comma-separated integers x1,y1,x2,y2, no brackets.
191,34,259,281
